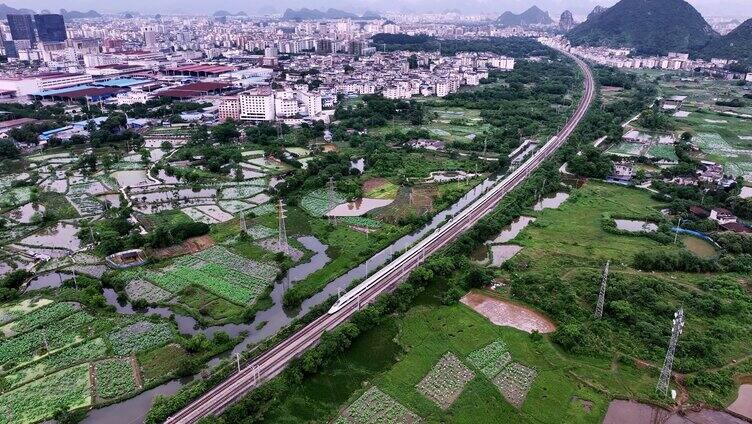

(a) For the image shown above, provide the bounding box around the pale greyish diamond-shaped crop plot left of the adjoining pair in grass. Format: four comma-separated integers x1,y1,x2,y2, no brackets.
416,352,475,409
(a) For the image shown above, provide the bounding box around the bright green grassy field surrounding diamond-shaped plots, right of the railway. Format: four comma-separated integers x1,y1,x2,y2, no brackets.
258,295,654,423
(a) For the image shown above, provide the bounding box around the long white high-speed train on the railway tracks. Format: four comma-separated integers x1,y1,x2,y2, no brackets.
329,136,559,314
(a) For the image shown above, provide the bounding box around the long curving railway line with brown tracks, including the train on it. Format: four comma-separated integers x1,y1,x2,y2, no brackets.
166,48,595,424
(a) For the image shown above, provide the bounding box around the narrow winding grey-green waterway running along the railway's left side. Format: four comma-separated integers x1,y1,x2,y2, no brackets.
85,176,500,424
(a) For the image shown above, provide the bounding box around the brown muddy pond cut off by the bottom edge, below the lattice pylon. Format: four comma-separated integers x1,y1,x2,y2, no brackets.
603,400,748,424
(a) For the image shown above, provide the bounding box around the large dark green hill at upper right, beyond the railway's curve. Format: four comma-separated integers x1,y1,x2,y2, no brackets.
567,0,718,55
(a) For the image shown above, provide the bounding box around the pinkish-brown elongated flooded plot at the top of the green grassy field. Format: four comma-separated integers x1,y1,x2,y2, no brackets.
460,291,556,333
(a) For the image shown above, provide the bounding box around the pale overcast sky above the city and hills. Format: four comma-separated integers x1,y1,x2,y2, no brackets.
10,0,752,19
